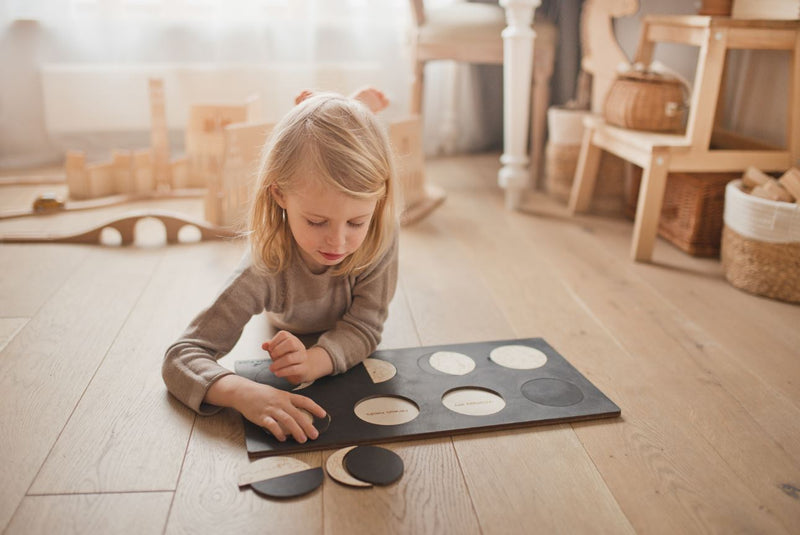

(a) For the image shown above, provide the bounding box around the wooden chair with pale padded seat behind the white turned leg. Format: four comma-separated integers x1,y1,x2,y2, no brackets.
409,0,558,182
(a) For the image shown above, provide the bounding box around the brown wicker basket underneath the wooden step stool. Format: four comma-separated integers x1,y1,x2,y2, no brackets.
625,167,741,257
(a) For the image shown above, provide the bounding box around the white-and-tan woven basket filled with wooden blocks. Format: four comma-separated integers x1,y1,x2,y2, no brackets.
722,180,800,303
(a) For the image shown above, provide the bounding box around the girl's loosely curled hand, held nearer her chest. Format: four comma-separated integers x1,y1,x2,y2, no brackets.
261,331,333,384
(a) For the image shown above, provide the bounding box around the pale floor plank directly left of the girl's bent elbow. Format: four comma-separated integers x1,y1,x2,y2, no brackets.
29,242,243,494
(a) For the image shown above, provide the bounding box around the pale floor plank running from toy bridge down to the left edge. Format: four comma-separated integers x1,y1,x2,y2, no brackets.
0,249,160,526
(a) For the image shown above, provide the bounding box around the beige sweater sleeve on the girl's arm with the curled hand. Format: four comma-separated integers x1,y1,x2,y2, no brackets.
317,234,398,374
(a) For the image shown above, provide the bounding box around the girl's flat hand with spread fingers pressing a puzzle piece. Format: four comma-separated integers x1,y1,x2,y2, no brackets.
205,375,325,444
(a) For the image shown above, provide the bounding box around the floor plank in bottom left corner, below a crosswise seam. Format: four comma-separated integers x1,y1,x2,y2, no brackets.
5,492,172,535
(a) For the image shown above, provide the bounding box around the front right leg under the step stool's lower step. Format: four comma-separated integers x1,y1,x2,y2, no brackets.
631,150,669,262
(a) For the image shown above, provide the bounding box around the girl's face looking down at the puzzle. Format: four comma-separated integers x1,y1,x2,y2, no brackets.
271,180,377,273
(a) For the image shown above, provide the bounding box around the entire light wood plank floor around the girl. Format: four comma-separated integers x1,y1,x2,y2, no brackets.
0,155,800,534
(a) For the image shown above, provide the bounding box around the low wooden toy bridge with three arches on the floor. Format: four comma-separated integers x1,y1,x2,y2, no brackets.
0,210,239,245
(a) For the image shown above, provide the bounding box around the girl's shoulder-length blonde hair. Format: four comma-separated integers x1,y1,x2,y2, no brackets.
250,93,397,275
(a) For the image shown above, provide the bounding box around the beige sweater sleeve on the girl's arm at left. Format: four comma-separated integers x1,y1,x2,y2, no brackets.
161,257,275,414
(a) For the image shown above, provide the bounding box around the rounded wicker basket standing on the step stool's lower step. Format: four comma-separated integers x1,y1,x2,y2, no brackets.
603,71,688,133
